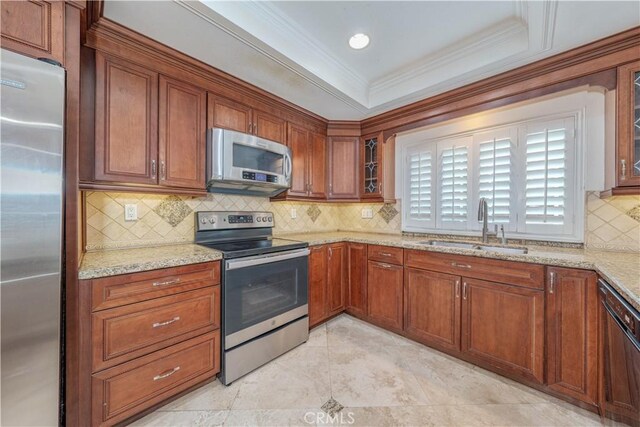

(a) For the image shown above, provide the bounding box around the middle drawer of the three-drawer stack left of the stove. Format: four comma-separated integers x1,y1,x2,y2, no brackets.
92,286,220,372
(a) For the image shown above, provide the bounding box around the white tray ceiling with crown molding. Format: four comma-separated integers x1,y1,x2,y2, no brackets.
104,0,640,120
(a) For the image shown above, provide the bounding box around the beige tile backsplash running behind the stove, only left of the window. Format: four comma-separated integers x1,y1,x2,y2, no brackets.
84,192,400,251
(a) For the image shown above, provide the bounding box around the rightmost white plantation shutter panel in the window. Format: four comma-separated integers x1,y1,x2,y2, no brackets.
523,120,574,232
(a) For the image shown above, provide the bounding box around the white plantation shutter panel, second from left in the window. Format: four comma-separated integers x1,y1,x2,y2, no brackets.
438,138,471,229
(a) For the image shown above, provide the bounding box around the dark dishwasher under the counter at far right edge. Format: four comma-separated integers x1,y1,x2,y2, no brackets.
598,279,640,427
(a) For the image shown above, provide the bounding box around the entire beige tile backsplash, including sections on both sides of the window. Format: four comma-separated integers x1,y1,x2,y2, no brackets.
85,192,640,252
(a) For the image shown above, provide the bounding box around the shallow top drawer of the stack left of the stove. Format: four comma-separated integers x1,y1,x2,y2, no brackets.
91,261,220,311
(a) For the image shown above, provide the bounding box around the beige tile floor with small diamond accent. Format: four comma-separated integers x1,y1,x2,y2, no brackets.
133,315,624,426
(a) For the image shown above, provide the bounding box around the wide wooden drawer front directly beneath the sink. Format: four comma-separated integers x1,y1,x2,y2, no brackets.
404,250,544,289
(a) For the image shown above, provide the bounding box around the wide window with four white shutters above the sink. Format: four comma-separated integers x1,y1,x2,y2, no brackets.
403,116,581,240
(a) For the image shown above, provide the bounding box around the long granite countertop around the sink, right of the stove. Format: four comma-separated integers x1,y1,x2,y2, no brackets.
278,231,640,310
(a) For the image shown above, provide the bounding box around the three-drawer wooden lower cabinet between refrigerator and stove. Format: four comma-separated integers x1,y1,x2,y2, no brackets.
78,262,221,426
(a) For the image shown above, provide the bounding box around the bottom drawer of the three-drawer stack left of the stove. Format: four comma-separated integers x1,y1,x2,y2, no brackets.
91,331,220,426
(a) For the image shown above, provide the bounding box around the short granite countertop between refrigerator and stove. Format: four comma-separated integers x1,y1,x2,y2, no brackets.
78,244,222,280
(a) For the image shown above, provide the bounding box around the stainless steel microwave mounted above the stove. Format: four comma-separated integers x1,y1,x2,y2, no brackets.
207,128,292,197
